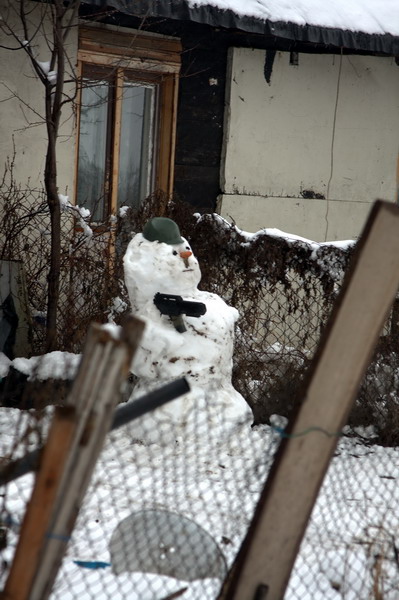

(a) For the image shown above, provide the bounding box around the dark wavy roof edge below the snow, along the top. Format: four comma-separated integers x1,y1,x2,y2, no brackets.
83,0,399,56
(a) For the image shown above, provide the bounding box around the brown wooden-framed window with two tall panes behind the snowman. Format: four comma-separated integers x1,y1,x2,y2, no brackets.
76,27,181,221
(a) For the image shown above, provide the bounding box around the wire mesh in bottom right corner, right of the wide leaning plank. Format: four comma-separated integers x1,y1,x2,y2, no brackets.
285,437,399,600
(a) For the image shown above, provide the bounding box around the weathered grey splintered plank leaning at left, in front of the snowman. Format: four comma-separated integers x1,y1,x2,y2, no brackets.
29,317,144,600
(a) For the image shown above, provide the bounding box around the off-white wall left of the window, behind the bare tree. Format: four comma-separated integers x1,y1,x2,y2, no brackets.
0,0,77,194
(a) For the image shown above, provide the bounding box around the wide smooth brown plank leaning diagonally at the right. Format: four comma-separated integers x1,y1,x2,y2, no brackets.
221,201,399,600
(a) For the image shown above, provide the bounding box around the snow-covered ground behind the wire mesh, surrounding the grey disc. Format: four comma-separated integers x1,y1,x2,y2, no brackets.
0,409,399,600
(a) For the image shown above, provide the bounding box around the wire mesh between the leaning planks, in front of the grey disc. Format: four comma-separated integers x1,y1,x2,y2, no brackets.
53,398,275,599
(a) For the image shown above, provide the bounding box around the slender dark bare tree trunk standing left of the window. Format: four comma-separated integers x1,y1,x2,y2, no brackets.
0,0,80,351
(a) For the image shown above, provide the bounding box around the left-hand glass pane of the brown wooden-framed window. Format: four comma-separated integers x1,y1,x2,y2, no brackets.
77,80,109,221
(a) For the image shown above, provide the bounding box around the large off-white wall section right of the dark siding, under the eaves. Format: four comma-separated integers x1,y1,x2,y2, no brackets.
220,48,399,241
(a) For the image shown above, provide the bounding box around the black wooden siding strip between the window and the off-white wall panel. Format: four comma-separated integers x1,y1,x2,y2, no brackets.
174,29,227,212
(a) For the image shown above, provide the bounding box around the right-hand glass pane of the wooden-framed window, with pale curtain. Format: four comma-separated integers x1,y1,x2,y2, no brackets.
118,81,156,207
